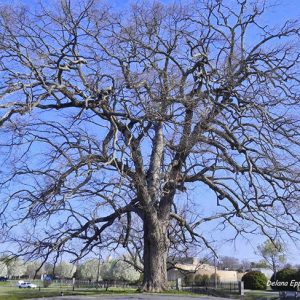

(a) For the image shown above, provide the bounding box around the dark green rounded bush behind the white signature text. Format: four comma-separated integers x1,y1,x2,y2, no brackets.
271,268,300,291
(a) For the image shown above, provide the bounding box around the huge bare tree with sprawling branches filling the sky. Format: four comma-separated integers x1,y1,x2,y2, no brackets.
0,0,300,291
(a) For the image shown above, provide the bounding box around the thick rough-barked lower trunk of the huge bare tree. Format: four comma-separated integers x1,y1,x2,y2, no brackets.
142,218,169,293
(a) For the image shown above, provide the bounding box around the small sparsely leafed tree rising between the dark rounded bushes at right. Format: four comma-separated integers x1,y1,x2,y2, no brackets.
257,240,286,280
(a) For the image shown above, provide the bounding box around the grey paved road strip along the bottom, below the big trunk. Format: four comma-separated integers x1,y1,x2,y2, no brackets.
32,294,230,300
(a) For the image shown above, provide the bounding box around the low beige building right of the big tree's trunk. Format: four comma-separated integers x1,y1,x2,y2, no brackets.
168,257,239,282
